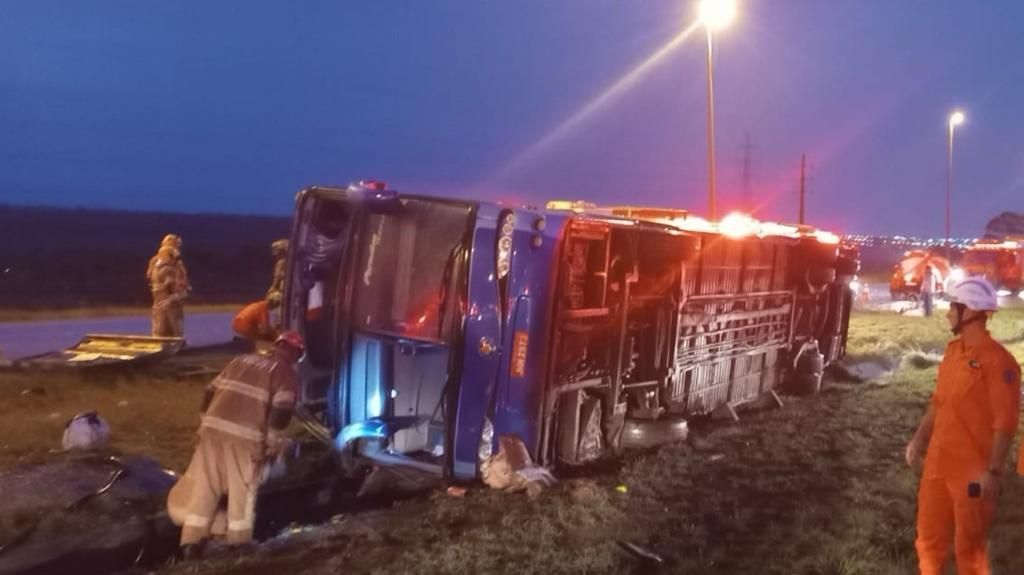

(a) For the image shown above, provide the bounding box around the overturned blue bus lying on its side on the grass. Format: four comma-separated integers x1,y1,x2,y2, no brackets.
284,182,858,480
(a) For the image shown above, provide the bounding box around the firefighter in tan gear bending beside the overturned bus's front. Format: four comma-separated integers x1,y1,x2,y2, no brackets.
181,331,303,557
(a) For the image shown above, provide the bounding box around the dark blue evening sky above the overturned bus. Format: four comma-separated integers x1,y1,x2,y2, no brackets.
0,0,1024,235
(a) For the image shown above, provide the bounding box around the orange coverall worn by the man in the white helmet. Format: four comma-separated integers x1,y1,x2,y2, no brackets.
915,333,1021,575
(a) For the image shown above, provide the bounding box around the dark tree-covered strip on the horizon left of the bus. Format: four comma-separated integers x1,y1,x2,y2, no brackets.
0,206,291,309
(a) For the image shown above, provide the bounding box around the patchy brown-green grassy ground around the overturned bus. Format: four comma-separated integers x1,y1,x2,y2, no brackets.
0,310,1024,575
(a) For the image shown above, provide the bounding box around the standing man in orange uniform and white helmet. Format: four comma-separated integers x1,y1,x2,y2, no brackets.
906,277,1021,575
